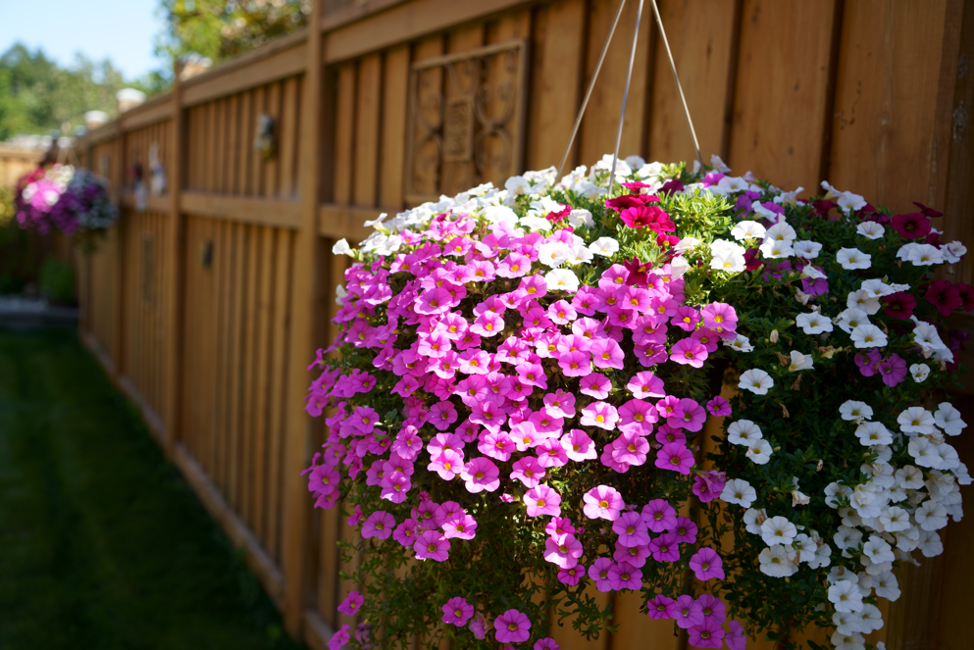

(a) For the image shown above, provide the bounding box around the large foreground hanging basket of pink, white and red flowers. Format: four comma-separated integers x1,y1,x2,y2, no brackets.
307,156,974,650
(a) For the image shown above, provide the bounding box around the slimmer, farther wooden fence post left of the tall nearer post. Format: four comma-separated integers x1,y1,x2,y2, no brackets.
163,61,186,460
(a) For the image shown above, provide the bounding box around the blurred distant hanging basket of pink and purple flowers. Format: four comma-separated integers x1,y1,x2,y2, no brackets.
14,164,118,247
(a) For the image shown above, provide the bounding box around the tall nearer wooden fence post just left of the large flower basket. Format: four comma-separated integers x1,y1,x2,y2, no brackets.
282,0,323,637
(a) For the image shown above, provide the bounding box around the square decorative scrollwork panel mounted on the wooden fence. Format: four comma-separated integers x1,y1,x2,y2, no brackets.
405,40,527,204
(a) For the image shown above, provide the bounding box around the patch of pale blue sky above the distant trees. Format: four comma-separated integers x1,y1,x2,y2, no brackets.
0,0,162,79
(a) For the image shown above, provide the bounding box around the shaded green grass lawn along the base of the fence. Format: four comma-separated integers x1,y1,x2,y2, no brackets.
0,330,304,650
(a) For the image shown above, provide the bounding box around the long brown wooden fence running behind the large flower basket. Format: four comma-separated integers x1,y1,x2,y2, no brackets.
80,0,974,650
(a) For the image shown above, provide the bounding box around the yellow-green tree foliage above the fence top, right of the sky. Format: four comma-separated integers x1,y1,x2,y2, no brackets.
156,0,311,62
